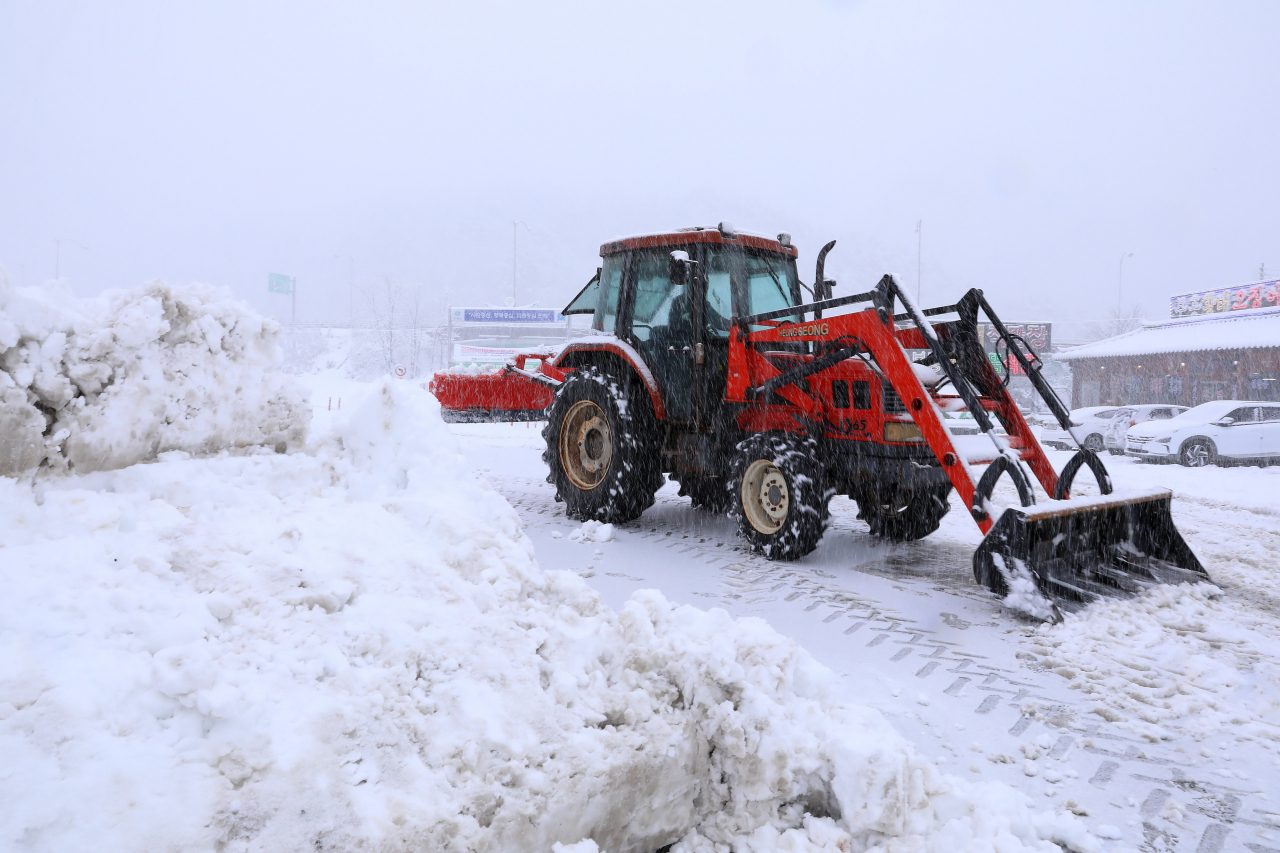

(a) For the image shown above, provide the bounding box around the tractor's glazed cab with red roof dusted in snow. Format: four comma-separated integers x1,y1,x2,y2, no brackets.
563,223,803,430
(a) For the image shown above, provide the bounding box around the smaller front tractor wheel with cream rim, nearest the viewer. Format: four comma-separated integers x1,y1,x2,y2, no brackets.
730,433,831,560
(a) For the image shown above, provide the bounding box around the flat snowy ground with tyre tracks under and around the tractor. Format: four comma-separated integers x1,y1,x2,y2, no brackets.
440,412,1280,853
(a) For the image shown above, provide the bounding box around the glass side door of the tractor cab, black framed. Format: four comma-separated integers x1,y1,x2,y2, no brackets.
630,250,700,424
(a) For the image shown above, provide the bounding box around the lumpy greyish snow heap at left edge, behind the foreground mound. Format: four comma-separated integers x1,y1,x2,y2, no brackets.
0,278,308,475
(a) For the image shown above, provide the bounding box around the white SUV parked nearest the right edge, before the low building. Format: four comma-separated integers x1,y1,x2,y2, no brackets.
1125,400,1280,467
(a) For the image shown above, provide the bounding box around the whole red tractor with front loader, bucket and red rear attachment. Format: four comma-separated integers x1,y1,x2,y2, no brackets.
430,224,1207,612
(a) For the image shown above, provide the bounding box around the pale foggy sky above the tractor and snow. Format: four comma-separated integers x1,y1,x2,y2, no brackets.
0,0,1280,338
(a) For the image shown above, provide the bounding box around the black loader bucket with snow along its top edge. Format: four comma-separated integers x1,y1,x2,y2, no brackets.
973,489,1208,617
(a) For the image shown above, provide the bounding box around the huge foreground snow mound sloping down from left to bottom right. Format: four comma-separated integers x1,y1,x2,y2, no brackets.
0,380,1097,853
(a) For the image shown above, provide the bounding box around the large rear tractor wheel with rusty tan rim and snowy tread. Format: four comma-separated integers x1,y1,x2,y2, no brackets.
543,366,663,524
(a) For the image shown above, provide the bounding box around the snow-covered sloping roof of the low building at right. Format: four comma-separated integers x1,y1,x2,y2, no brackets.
1055,309,1280,361
